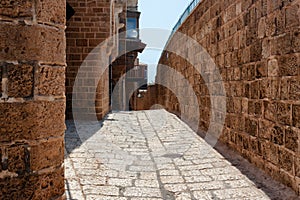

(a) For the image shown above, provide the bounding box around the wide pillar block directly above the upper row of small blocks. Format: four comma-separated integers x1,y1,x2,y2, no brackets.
0,23,66,65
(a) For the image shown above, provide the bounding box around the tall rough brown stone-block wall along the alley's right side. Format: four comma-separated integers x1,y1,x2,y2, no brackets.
157,0,300,194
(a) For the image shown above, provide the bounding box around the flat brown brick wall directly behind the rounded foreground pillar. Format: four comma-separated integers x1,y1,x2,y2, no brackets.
66,0,118,119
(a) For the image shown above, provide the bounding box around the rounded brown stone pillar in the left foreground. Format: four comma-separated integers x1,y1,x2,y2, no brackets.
0,0,66,199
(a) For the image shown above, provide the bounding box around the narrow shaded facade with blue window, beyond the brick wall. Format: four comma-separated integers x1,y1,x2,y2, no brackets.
110,4,146,111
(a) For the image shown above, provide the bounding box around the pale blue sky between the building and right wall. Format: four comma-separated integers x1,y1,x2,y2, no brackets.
138,0,191,82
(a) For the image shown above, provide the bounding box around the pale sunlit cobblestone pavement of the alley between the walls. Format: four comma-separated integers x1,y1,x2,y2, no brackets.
65,110,297,200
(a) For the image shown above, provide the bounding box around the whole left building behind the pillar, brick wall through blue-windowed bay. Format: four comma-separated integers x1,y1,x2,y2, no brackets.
66,1,145,119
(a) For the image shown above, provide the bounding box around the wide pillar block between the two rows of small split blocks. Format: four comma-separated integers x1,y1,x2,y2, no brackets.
0,101,65,142
